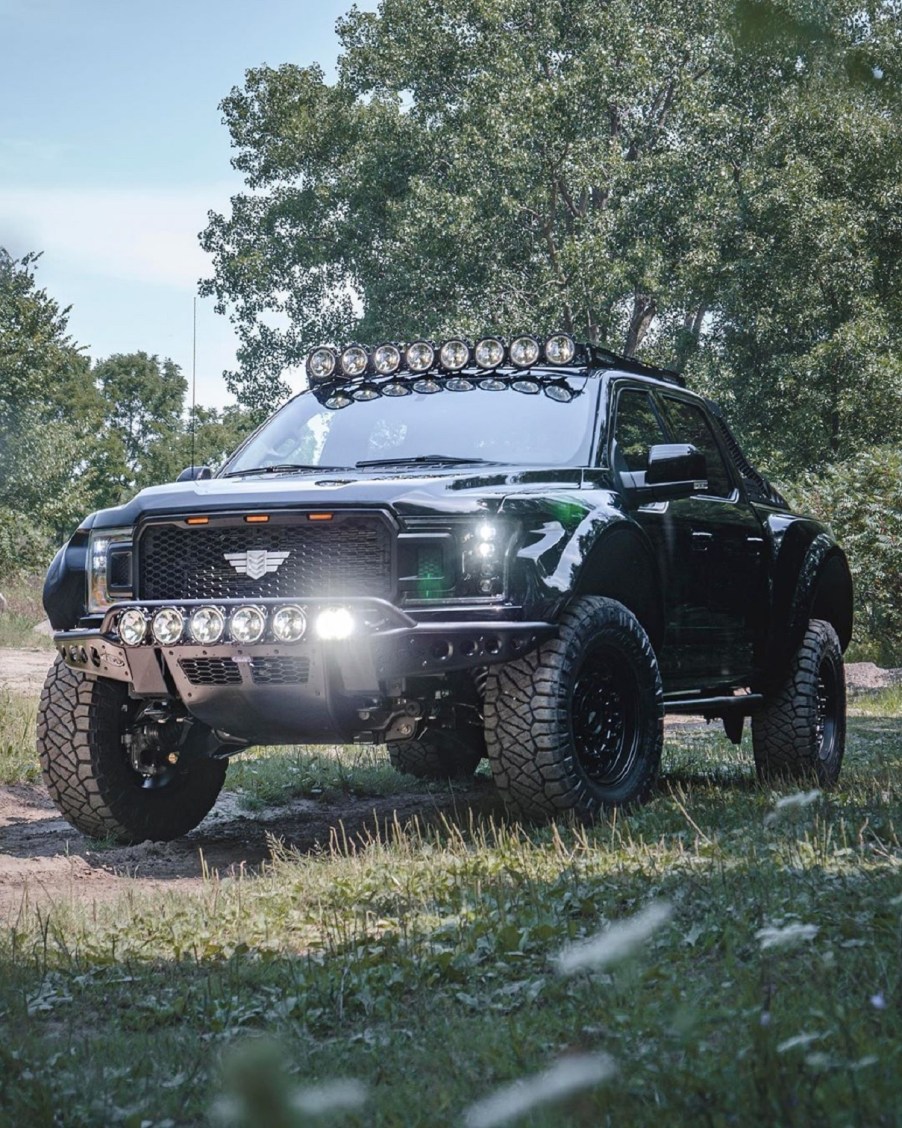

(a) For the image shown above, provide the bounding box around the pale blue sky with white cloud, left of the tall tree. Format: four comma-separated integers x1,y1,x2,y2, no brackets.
0,0,375,406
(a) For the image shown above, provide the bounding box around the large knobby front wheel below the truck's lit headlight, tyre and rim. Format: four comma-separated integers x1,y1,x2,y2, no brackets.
485,596,664,821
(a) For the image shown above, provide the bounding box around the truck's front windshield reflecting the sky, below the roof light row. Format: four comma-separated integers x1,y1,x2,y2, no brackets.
222,376,599,475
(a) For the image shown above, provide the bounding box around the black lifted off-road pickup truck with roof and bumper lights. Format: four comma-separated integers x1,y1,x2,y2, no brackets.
37,334,852,841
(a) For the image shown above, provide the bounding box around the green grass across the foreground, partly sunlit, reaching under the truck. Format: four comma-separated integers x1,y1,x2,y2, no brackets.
0,698,902,1128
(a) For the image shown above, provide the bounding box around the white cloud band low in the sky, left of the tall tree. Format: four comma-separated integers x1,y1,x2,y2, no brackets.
0,184,229,291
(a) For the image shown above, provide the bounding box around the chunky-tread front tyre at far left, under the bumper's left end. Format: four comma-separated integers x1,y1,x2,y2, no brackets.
37,656,227,845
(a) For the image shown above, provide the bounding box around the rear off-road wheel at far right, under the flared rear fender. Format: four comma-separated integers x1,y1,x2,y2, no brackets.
752,619,846,787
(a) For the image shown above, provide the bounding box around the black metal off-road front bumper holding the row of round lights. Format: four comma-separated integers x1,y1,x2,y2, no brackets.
54,598,557,742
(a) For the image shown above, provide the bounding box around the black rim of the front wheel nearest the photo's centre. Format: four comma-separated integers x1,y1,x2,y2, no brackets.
571,647,638,788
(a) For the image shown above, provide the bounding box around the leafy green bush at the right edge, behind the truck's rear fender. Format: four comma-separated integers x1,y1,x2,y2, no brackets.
797,447,902,666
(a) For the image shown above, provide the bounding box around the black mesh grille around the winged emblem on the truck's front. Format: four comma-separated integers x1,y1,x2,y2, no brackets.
138,517,392,599
